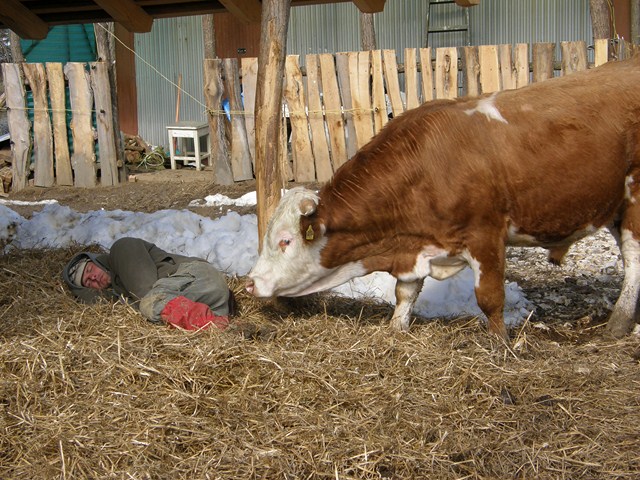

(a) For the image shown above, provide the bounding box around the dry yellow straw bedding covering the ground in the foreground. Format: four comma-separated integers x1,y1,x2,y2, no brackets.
0,244,640,479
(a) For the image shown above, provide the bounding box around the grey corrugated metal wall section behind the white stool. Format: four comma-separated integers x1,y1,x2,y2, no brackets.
135,16,206,148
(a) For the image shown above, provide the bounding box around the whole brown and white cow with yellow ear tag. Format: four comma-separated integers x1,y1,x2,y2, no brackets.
246,56,640,338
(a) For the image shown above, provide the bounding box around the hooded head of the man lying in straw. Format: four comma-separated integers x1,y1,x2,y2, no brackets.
62,252,111,303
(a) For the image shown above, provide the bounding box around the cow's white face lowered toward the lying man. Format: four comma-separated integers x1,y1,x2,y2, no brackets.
246,187,366,297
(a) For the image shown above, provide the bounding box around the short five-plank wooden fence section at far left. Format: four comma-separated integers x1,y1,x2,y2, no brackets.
2,62,119,191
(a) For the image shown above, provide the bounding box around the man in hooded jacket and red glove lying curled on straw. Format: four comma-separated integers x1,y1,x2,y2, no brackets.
62,237,235,330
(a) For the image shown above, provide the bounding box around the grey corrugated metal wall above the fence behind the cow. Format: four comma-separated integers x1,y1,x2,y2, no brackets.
287,0,592,62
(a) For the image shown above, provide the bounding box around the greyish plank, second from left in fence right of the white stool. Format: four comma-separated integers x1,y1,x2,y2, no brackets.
222,58,253,181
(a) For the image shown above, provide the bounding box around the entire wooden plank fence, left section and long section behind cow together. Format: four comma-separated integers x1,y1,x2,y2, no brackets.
2,40,631,191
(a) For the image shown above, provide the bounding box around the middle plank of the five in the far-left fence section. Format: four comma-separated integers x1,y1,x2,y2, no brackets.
46,63,73,185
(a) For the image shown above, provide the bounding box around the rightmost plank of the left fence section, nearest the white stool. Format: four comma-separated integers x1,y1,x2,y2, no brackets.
90,62,119,186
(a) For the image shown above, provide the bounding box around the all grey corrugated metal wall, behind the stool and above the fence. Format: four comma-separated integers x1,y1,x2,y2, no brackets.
135,0,592,146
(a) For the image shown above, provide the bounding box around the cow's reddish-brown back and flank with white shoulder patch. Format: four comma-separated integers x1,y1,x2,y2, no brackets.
321,58,640,248
